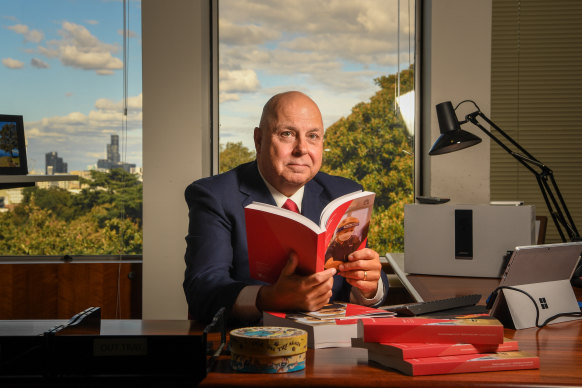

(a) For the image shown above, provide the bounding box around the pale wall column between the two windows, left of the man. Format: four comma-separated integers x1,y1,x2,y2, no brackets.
142,0,210,319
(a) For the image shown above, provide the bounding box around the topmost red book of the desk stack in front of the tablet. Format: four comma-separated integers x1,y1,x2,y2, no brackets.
358,317,503,344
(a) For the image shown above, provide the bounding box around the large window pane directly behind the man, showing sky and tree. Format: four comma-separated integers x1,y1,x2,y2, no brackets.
218,0,415,254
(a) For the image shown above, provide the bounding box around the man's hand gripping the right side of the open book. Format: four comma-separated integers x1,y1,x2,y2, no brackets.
339,248,382,299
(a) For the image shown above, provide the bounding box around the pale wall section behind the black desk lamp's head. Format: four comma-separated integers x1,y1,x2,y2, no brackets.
422,0,491,203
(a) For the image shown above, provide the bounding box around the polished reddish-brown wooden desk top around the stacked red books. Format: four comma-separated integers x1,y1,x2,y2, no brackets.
200,276,582,388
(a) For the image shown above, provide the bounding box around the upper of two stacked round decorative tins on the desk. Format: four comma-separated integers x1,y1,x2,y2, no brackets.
230,326,307,357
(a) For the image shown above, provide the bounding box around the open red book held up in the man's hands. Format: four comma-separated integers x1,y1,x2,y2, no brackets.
245,191,375,283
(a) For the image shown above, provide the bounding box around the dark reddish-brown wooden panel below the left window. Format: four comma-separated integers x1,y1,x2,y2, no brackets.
0,262,142,319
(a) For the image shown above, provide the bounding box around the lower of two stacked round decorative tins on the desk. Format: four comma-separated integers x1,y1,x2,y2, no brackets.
230,353,306,373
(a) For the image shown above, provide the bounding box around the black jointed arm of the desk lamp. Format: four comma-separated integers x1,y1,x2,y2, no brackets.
465,110,581,242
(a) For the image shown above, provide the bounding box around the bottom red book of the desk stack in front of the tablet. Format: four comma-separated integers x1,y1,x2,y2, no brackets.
368,351,540,376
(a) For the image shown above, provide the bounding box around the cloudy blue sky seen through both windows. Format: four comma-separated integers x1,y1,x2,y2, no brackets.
0,0,415,173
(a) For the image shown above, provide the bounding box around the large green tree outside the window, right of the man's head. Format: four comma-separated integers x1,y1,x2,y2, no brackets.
322,67,414,254
